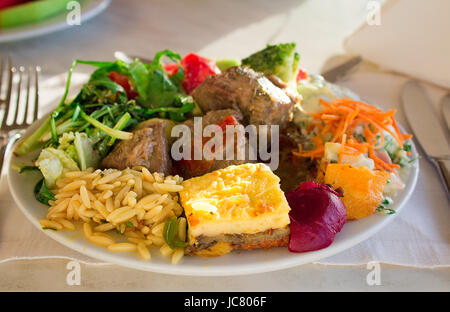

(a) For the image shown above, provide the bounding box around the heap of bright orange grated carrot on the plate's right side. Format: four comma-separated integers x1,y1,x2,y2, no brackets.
293,98,412,172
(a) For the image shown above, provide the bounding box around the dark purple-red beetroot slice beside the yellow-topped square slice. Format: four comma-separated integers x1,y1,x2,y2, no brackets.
286,182,347,252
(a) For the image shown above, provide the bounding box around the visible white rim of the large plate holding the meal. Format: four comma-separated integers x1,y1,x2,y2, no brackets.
8,89,419,276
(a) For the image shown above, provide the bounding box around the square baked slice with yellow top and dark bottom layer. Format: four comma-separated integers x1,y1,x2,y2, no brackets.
180,163,290,257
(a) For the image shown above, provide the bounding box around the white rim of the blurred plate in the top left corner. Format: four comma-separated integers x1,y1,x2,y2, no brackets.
0,0,111,43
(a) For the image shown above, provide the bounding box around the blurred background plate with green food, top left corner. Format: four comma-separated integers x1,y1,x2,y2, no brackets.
0,0,111,43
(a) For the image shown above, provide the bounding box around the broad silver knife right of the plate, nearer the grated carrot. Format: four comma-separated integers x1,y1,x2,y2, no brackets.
402,81,450,196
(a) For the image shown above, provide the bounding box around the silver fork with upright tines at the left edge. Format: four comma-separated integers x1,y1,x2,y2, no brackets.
0,56,41,174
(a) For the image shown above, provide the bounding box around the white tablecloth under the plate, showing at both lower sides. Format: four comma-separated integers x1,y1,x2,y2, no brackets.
0,71,450,267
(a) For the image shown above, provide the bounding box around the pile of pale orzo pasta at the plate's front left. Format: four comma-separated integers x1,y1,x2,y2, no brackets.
40,167,186,263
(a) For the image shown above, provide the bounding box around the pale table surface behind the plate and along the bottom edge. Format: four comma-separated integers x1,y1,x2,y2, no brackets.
0,0,450,291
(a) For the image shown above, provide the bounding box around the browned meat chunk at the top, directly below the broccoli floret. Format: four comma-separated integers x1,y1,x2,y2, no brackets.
192,66,300,127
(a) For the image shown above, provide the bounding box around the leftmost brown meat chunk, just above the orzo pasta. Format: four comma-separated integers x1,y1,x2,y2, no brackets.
100,120,172,175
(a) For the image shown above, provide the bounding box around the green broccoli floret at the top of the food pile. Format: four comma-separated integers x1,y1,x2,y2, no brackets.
242,43,300,83
